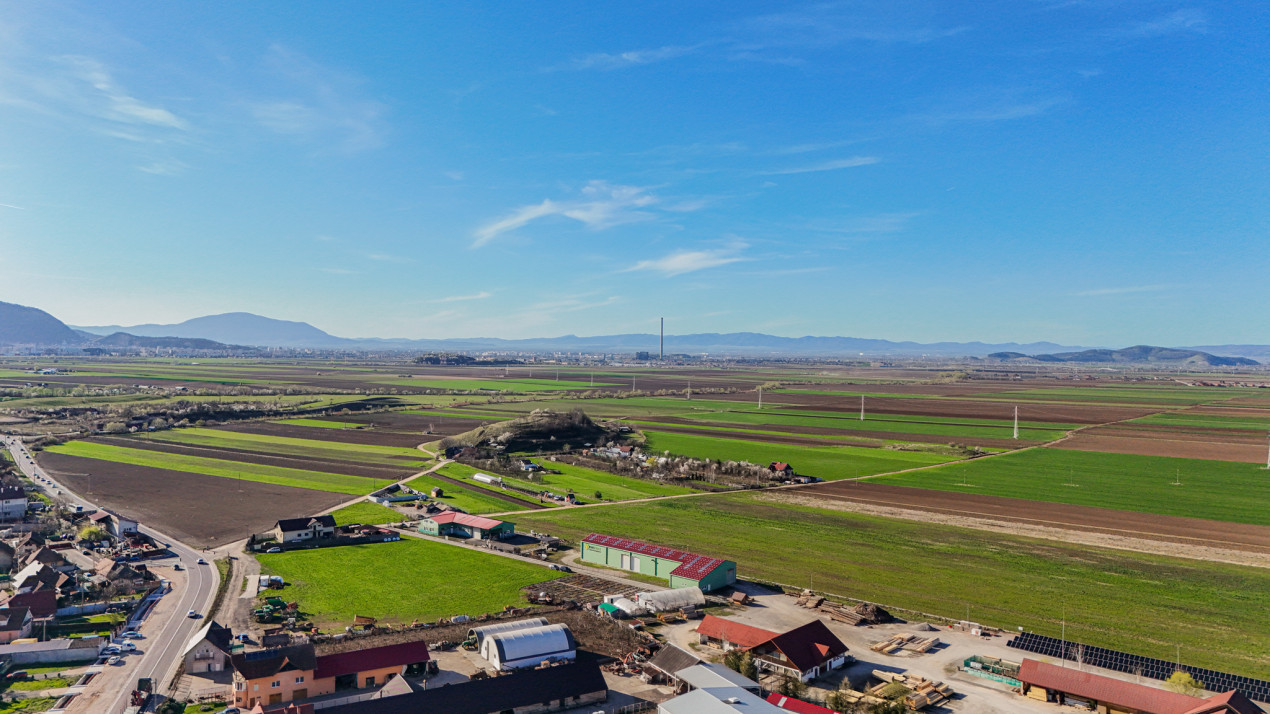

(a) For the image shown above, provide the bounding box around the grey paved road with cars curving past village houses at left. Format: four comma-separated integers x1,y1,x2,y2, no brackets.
3,436,220,714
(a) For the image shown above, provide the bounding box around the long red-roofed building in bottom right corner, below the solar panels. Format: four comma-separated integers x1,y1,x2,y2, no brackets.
1019,659,1261,714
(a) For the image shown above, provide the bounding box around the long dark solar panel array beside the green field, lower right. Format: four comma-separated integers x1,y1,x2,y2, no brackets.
1006,633,1270,701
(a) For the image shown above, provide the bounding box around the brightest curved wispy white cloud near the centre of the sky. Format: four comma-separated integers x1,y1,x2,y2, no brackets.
471,180,658,248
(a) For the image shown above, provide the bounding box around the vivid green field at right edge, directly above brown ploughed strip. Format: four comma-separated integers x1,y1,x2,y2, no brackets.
870,448,1270,525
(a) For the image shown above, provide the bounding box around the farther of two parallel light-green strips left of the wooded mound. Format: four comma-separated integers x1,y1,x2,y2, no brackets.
136,428,427,469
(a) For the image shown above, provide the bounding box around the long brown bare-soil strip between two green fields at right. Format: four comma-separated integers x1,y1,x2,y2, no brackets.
785,480,1270,554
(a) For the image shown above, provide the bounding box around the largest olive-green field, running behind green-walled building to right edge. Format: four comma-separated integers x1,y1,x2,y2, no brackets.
517,493,1270,677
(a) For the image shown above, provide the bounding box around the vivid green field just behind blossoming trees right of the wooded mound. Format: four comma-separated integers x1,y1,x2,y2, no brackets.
644,431,950,480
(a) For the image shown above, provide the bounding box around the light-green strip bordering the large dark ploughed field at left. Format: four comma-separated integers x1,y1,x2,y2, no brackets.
48,441,370,495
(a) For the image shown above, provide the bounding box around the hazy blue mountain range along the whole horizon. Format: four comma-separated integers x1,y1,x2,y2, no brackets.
0,297,1254,358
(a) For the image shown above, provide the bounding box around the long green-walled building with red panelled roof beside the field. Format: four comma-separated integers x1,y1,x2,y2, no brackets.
582,534,737,592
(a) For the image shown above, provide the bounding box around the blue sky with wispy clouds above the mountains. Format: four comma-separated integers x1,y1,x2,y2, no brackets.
0,0,1270,346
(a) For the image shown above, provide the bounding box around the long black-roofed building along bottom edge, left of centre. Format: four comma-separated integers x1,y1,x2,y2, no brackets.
321,652,608,714
